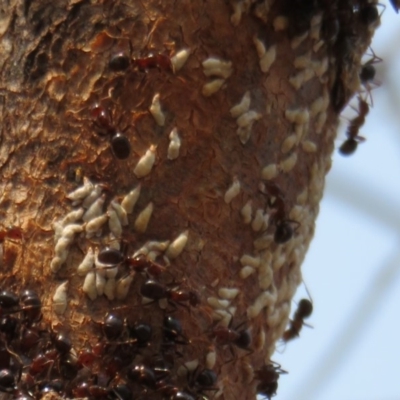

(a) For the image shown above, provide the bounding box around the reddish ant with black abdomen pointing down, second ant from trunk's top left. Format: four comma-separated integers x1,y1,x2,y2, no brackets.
91,103,131,160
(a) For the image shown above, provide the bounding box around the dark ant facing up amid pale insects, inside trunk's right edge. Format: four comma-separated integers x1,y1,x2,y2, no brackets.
259,183,300,244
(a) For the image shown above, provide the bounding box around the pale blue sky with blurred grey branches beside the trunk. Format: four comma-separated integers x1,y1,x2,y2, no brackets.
273,1,400,400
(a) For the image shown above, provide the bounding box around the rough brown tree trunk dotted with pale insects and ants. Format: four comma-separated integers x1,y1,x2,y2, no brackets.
0,0,379,400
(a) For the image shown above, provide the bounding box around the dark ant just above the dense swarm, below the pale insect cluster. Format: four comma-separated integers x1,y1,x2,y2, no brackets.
140,279,199,307
